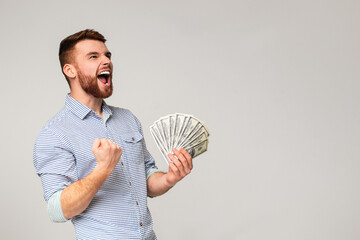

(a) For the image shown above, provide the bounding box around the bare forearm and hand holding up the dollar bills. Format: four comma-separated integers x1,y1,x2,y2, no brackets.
147,148,193,197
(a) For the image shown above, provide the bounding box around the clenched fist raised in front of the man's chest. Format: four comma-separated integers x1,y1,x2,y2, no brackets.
92,138,122,173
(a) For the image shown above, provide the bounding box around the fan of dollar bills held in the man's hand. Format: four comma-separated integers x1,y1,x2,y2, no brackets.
150,113,209,163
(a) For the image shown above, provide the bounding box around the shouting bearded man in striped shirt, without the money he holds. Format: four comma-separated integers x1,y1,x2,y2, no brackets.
34,30,193,240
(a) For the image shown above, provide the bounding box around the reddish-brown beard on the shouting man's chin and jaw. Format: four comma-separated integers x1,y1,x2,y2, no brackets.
77,69,113,99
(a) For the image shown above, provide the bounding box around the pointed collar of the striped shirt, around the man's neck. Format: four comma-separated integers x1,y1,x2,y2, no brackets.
65,93,112,120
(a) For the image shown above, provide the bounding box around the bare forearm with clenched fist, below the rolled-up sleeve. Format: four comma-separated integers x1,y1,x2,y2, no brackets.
60,138,122,219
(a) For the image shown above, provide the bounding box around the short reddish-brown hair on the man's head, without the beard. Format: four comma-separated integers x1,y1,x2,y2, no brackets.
59,29,106,85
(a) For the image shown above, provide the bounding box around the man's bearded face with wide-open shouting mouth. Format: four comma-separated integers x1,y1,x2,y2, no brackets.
74,39,113,98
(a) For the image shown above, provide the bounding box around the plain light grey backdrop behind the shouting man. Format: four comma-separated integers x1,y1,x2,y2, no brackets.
0,0,360,240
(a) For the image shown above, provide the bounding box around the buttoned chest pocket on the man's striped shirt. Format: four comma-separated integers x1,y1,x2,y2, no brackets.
120,131,144,163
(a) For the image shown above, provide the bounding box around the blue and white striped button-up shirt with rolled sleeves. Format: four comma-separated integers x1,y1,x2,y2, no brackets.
34,95,158,240
